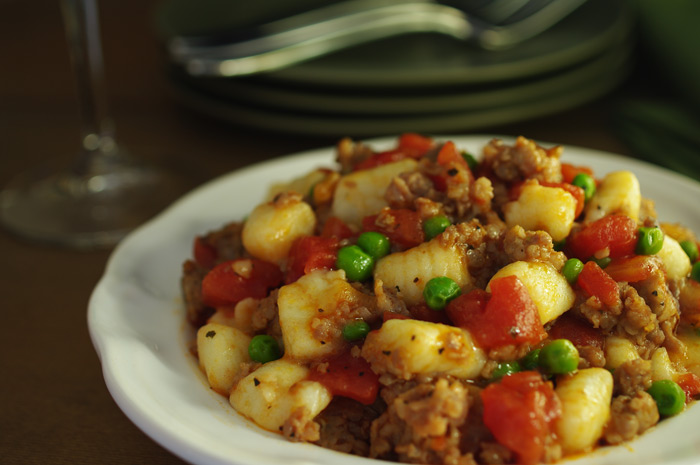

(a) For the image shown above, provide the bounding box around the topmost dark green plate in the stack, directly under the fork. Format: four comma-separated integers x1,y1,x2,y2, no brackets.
156,0,632,89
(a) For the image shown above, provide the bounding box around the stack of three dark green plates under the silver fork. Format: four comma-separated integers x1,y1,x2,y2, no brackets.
158,0,634,136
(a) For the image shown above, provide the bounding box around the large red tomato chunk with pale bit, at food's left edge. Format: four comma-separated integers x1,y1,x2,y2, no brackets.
202,258,283,307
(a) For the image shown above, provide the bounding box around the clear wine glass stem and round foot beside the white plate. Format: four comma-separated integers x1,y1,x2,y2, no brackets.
0,0,186,248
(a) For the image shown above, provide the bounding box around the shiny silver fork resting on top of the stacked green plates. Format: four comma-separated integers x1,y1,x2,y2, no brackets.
168,0,586,77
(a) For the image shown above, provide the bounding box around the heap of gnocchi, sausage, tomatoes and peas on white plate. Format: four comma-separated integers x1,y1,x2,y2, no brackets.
182,133,700,464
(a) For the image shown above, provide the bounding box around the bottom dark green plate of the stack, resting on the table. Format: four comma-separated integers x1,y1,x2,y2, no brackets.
171,44,631,137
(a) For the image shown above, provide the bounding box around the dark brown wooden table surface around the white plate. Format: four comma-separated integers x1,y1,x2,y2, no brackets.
0,0,664,465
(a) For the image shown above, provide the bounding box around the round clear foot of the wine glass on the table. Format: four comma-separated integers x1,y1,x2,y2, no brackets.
0,160,188,249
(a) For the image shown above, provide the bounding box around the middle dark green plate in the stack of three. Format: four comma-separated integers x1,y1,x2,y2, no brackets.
172,37,631,116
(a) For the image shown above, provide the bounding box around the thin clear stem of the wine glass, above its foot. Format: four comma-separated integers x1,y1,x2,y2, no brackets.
61,0,118,175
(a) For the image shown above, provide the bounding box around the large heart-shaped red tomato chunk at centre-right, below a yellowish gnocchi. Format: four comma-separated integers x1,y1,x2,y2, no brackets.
446,275,547,349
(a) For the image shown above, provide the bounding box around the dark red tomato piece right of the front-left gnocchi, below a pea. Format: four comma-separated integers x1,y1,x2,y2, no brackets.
309,352,379,405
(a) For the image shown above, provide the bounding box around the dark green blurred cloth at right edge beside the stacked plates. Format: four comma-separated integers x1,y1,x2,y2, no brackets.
613,0,700,180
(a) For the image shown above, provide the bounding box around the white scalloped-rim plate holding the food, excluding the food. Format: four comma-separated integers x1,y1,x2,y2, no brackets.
88,136,700,465
